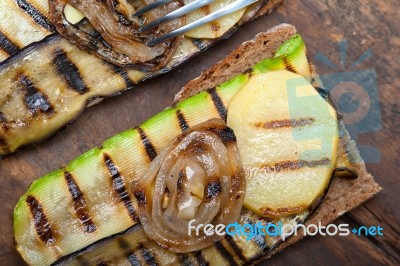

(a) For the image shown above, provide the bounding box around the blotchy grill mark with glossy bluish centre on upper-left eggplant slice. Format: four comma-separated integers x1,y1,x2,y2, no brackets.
19,75,54,115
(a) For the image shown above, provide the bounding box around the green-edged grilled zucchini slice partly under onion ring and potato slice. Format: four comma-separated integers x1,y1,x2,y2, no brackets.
14,35,308,265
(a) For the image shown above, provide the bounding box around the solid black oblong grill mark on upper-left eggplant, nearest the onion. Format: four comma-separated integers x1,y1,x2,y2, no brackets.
53,49,89,94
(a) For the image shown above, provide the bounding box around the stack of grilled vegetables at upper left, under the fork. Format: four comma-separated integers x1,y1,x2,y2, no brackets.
0,0,268,157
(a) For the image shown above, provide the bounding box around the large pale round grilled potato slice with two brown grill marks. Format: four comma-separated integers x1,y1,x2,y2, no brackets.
228,70,338,218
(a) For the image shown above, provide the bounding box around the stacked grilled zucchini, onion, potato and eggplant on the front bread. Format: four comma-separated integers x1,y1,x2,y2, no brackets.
14,35,345,265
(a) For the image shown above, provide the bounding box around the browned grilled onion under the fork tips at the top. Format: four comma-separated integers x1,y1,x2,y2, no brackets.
49,0,183,71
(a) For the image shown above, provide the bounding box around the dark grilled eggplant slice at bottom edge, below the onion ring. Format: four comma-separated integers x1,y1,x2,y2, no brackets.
52,210,310,266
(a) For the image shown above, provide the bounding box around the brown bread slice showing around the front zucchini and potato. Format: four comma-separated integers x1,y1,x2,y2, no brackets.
175,24,381,261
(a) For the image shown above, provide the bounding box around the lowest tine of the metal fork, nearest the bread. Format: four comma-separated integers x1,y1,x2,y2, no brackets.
146,0,258,46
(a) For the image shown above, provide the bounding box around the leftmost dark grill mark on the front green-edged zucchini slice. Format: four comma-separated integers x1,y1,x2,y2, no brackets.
26,195,56,245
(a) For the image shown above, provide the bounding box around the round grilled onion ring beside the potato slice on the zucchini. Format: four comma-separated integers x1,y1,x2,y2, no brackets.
133,119,245,253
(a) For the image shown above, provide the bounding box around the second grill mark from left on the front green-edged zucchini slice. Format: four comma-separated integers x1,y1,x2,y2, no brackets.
64,171,97,233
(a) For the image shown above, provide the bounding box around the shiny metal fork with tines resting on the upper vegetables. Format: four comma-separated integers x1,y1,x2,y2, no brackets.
134,0,258,46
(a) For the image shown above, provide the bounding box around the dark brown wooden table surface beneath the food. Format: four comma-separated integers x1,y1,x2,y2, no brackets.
0,0,400,265
